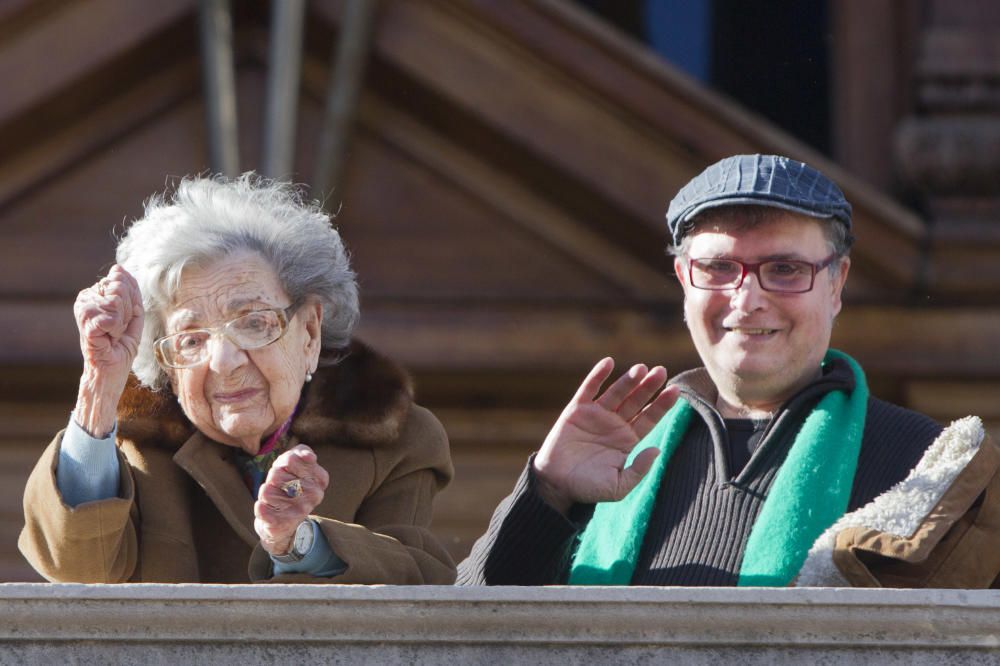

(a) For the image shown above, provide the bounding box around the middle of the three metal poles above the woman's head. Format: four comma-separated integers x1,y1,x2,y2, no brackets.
261,0,306,179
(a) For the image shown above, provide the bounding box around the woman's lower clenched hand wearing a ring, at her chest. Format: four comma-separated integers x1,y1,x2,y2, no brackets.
253,444,330,555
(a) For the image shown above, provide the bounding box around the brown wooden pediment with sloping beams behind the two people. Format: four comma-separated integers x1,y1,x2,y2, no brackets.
0,0,960,360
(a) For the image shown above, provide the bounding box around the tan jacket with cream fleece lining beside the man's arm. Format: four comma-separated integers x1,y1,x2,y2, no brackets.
795,416,1000,588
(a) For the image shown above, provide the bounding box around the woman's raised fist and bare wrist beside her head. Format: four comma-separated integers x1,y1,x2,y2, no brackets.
73,264,144,437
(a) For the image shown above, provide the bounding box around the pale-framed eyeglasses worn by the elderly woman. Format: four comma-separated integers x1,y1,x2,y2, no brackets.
153,303,298,369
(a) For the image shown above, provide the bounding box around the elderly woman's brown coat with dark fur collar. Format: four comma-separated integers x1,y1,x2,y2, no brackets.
18,343,455,585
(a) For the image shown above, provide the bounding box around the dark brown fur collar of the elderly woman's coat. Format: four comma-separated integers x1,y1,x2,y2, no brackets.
118,341,413,449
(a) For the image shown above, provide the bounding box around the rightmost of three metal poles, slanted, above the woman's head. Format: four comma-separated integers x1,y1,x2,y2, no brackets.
313,0,378,201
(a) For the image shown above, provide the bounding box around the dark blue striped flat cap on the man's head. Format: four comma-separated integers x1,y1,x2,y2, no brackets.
667,155,851,245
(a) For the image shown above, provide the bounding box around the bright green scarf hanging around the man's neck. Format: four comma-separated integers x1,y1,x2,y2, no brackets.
568,349,868,587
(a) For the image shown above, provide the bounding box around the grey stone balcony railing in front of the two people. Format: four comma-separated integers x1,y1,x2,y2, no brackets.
0,583,1000,666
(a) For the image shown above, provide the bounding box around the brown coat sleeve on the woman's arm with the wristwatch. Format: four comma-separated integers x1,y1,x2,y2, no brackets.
250,405,455,585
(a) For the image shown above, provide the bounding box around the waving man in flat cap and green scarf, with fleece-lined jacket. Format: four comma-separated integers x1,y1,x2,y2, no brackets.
458,155,1000,587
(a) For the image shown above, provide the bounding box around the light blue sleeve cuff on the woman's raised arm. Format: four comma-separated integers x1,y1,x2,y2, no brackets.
56,416,118,507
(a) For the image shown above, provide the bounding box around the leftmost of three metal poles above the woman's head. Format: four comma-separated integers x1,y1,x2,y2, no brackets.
199,0,240,176
